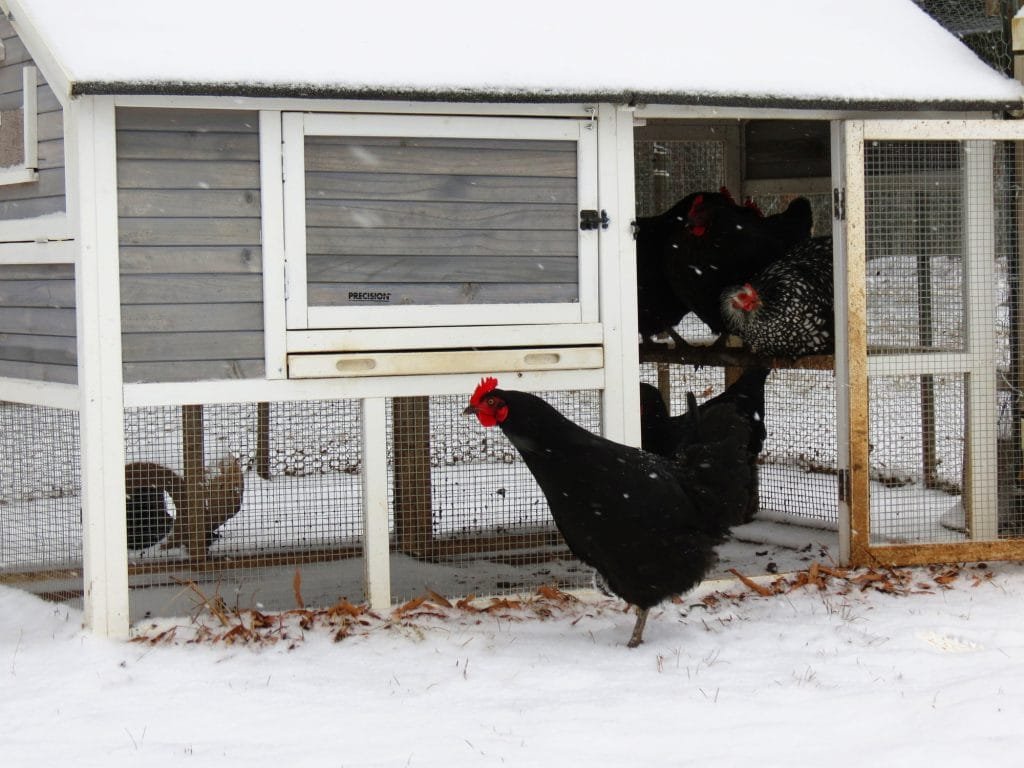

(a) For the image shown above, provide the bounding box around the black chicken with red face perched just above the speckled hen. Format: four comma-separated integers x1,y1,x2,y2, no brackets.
665,187,813,334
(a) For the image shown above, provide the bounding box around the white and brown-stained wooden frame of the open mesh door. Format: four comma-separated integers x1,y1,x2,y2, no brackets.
834,120,1024,565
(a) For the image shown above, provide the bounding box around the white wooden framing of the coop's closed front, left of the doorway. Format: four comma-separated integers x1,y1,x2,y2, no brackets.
74,96,639,637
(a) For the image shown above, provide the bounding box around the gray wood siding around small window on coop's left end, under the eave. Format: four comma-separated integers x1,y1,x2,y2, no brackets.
0,16,67,220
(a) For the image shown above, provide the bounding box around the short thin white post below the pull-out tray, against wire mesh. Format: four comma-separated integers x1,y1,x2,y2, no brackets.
362,397,391,610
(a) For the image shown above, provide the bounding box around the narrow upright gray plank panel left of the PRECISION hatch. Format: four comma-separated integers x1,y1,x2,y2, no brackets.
117,109,264,382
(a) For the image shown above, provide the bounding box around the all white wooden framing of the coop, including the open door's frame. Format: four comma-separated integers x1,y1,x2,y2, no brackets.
9,96,1024,637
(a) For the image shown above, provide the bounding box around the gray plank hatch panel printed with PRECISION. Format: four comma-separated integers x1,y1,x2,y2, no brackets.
305,136,579,306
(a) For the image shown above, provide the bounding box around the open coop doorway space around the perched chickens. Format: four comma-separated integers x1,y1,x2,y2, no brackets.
634,118,843,575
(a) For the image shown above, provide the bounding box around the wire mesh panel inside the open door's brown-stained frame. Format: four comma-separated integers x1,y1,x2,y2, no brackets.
865,140,1024,554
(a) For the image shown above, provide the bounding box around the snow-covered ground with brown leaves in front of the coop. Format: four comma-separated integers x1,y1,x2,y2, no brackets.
0,563,1024,768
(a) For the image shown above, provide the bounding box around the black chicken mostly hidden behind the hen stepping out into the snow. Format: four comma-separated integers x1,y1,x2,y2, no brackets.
640,367,770,522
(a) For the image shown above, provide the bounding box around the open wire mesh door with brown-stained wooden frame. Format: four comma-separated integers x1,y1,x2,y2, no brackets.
840,121,1024,564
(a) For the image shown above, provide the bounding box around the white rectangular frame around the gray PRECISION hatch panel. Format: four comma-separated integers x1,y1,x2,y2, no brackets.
282,113,599,333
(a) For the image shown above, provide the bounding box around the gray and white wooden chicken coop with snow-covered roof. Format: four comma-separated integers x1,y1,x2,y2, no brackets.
0,0,1024,637
